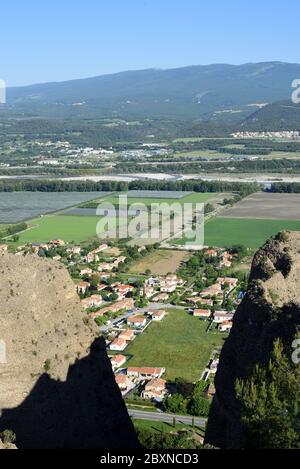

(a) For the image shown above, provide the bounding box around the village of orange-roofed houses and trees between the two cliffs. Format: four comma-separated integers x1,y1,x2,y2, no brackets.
0,239,243,412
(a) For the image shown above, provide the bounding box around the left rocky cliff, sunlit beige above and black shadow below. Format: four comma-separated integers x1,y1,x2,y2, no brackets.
0,250,138,449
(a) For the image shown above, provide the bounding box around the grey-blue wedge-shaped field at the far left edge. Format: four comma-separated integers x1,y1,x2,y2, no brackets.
0,192,110,223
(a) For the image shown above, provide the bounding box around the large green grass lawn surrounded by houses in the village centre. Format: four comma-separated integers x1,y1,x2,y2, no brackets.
126,309,225,382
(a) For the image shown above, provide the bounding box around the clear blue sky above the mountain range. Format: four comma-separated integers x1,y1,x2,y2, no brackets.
0,0,300,86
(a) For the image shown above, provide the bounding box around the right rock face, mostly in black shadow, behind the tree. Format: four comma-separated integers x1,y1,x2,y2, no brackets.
206,232,300,448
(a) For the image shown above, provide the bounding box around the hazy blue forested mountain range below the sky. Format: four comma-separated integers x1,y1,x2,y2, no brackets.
2,62,300,126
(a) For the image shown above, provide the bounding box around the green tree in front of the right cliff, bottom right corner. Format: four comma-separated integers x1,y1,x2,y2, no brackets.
236,340,300,449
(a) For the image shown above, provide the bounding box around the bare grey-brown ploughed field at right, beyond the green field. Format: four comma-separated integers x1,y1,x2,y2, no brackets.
222,192,300,220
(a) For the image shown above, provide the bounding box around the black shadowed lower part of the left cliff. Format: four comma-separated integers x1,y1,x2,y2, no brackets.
0,339,139,449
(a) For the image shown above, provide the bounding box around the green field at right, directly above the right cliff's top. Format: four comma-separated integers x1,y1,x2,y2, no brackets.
205,217,300,249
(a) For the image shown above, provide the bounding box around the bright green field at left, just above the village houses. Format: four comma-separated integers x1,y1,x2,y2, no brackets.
18,215,125,244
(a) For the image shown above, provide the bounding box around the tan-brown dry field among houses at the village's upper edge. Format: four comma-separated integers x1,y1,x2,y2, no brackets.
130,250,188,275
